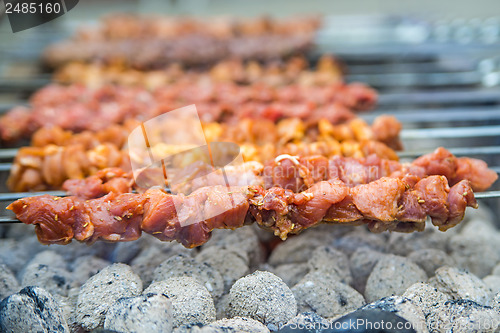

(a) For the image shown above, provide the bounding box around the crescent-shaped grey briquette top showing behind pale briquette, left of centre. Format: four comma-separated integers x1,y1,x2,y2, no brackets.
153,254,224,299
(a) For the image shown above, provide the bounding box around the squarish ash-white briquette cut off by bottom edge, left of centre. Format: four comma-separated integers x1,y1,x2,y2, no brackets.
104,294,173,333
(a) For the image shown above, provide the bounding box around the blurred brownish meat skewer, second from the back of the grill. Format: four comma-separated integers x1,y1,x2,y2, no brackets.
43,34,312,70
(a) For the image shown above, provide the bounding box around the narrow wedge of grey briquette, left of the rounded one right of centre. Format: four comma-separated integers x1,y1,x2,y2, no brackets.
349,247,385,295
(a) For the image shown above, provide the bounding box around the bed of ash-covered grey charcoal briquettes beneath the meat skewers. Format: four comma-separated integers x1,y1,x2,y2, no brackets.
0,207,500,333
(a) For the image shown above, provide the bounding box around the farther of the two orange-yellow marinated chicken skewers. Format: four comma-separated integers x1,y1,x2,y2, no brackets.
31,115,402,150
